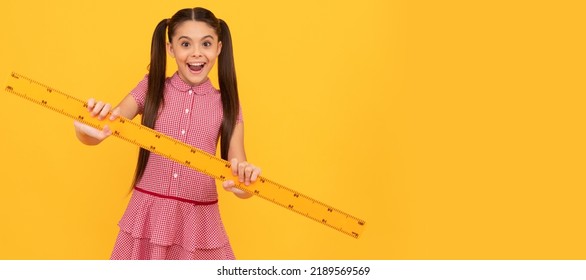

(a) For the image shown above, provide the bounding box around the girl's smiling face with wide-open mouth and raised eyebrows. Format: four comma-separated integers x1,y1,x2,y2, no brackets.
167,20,222,85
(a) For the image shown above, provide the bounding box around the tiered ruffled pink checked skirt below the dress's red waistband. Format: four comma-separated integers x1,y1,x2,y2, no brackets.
111,191,235,260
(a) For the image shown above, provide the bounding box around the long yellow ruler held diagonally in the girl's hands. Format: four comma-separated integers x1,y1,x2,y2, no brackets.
6,73,365,238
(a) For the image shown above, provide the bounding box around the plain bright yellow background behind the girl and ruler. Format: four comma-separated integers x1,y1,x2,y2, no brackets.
0,0,586,259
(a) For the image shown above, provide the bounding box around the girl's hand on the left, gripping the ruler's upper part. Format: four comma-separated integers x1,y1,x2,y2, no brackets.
73,98,120,144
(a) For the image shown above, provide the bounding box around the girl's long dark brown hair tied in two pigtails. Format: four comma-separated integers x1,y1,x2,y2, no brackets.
133,7,240,186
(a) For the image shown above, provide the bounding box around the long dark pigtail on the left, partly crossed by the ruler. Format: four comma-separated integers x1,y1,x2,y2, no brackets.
132,19,168,186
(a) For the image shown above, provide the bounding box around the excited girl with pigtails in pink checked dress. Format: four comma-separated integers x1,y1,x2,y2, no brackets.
75,8,261,259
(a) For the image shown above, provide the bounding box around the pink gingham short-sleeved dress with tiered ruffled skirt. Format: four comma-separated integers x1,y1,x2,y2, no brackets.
111,73,242,259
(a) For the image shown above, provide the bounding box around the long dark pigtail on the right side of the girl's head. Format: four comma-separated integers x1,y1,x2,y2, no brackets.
218,19,240,160
